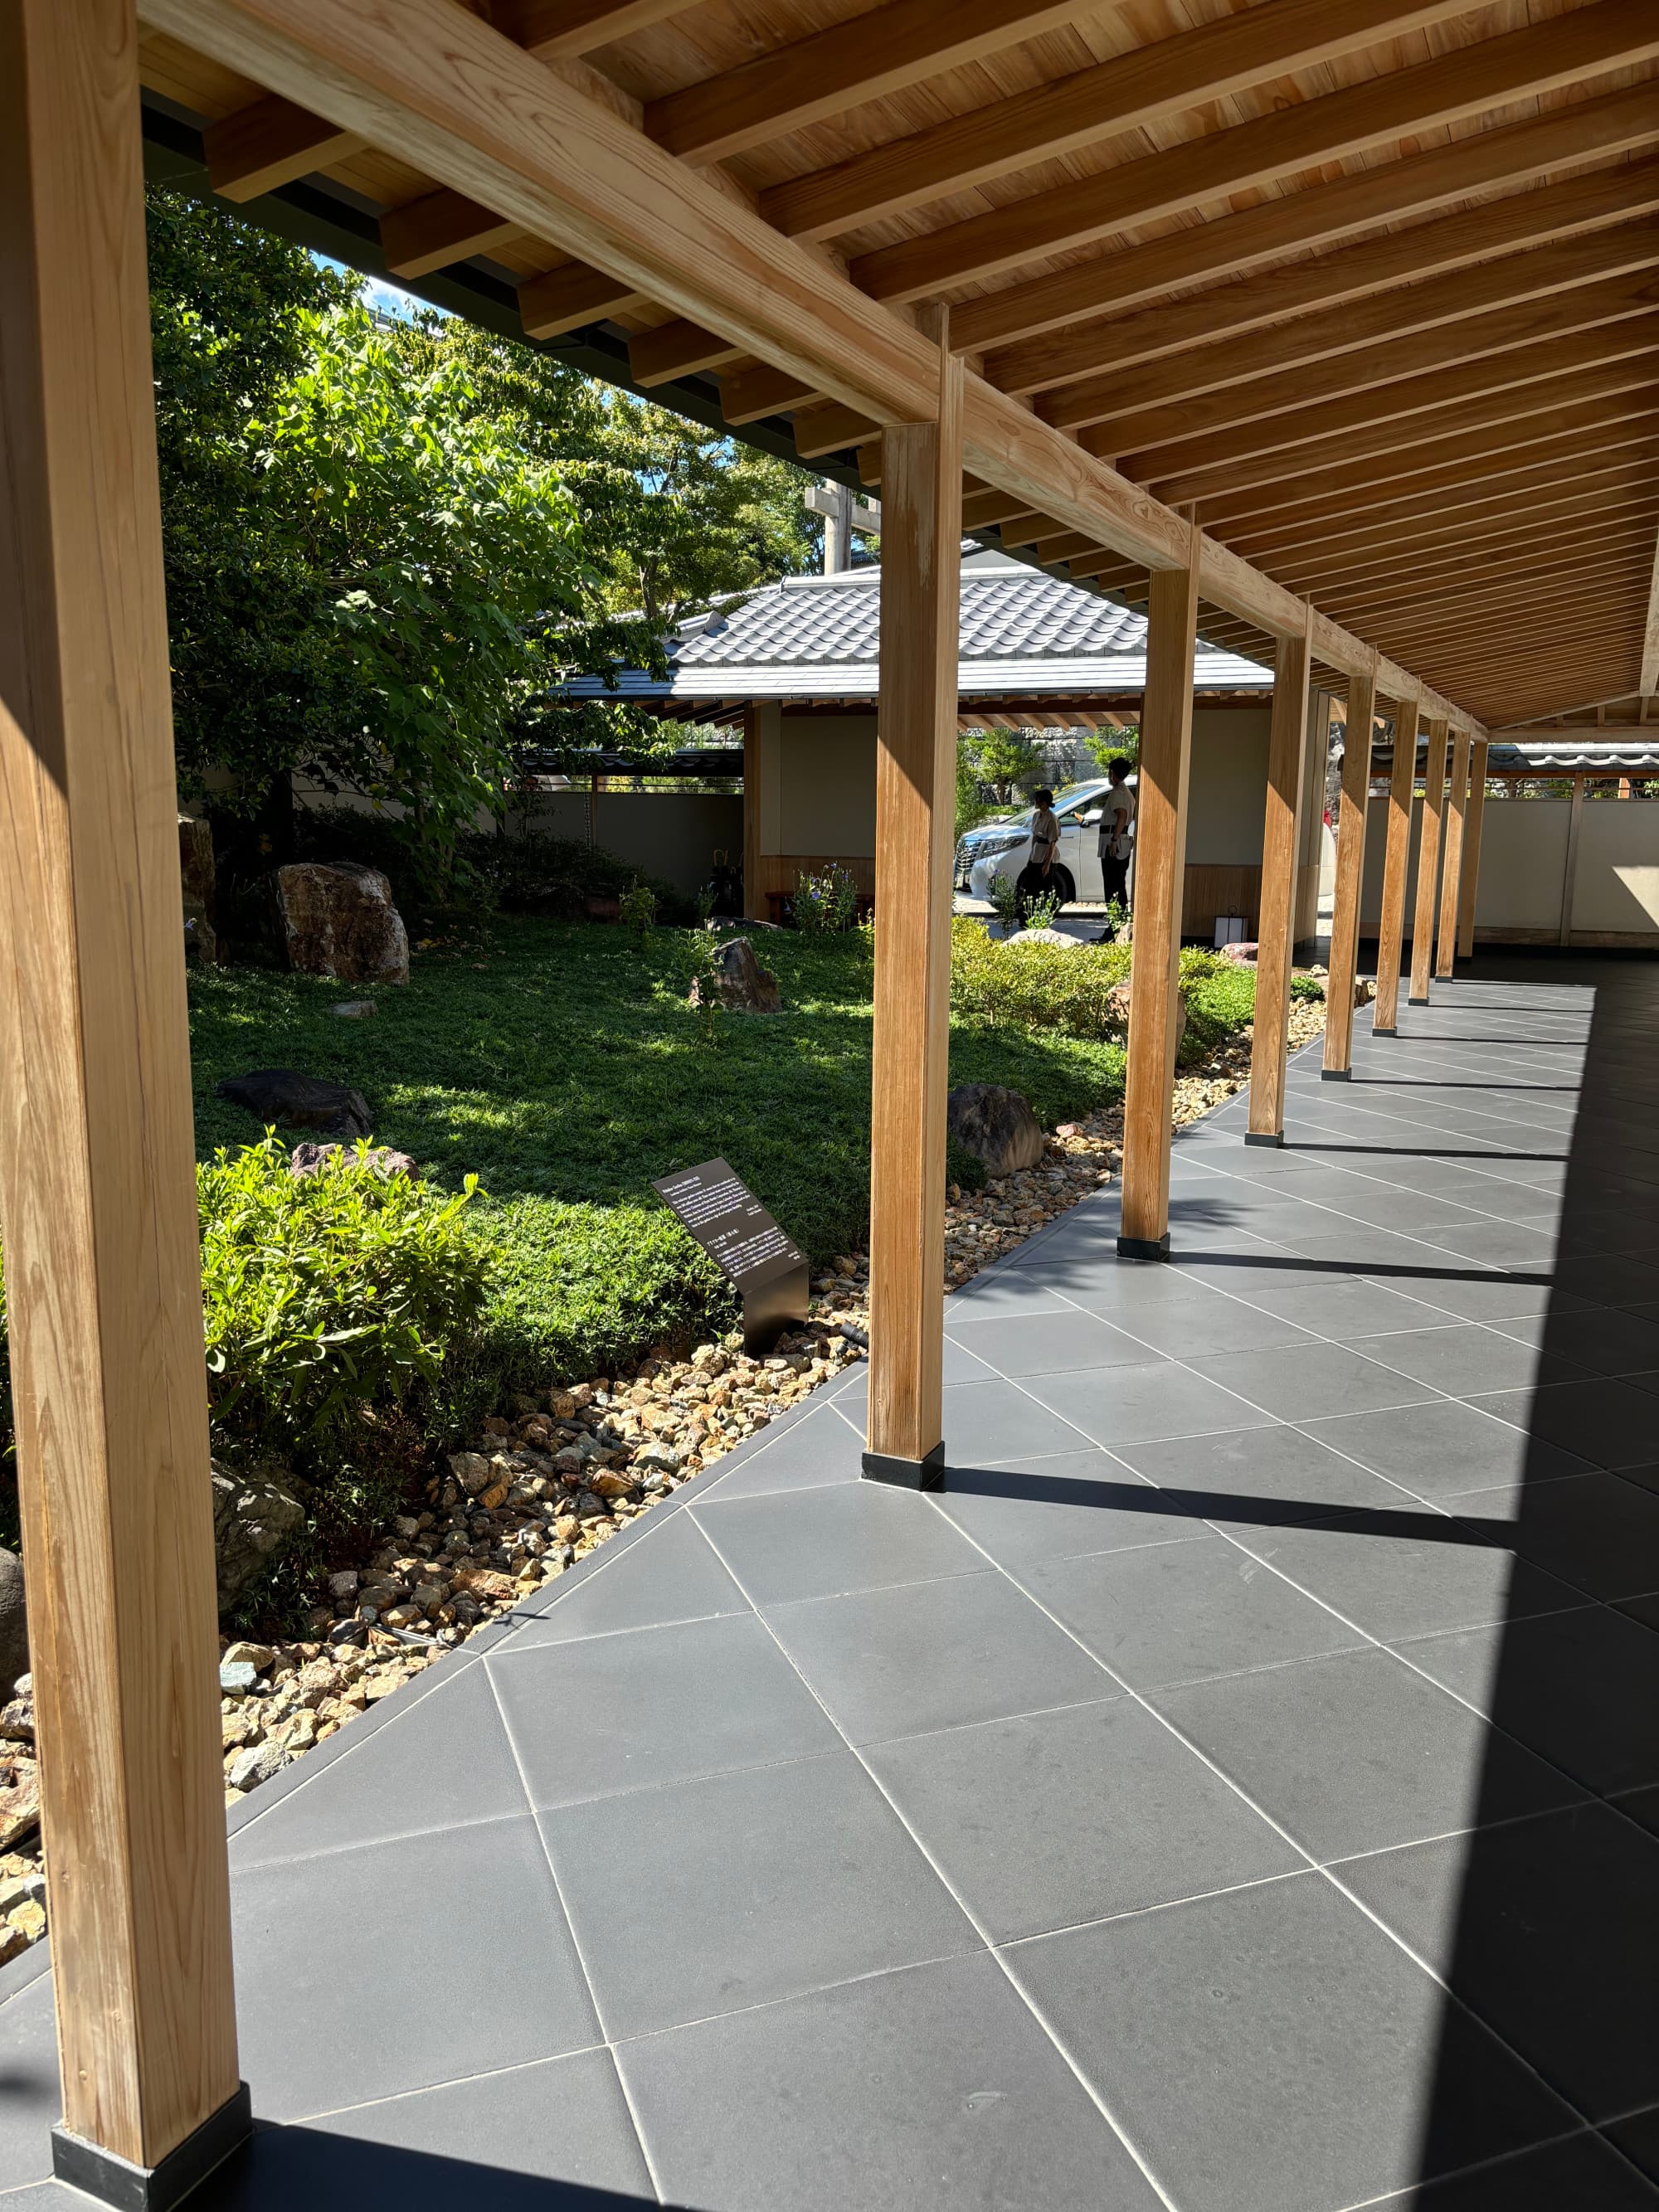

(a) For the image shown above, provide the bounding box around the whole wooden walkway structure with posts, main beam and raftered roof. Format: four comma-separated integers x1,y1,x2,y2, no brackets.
0,0,1659,2205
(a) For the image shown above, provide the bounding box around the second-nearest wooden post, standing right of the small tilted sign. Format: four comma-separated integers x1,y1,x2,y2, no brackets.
863,343,962,1489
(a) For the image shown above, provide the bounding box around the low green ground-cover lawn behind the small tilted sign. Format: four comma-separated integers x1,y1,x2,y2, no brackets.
190,918,1254,1380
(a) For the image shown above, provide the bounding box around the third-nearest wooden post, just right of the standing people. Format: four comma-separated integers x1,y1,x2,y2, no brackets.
1117,527,1199,1259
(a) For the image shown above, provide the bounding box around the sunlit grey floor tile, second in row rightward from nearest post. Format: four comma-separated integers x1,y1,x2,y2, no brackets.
542,1752,980,2037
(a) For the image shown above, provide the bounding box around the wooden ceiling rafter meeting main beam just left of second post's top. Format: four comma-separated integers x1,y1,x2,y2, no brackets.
849,0,1659,299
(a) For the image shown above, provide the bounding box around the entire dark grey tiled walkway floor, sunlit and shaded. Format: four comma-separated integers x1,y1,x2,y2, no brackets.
0,960,1659,2212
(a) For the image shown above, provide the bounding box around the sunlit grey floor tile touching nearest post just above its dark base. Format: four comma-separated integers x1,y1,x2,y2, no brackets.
230,1814,600,2119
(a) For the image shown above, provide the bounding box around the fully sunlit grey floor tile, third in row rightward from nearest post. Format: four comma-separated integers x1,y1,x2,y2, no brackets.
869,1697,1303,1942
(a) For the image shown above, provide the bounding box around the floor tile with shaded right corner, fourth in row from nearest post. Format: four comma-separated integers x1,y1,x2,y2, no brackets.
1152,1650,1579,1860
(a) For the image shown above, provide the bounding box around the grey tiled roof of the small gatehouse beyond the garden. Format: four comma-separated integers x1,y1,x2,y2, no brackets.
568,555,1272,699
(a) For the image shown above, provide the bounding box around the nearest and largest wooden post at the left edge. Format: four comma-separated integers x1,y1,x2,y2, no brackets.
0,0,248,2203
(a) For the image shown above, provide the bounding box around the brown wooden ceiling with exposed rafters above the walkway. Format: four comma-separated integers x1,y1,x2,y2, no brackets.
139,0,1659,723
